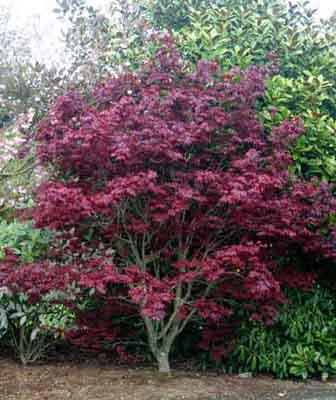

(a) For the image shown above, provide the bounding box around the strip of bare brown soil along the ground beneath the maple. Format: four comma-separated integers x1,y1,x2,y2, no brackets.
0,359,336,400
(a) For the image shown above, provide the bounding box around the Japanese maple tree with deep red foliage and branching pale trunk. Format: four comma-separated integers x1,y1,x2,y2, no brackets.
3,39,336,372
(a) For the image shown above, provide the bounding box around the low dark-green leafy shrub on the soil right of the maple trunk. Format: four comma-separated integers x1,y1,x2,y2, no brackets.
226,288,336,379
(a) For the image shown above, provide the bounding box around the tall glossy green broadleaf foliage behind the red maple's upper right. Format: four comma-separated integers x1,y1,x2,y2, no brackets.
109,0,336,183
